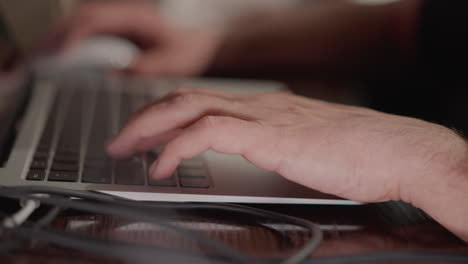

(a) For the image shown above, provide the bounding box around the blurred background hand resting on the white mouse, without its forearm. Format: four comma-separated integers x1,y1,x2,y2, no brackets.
40,1,220,76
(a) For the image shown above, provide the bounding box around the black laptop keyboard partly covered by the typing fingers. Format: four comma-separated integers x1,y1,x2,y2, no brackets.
26,76,210,188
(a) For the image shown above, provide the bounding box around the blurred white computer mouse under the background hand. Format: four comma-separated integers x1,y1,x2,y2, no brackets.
32,36,140,74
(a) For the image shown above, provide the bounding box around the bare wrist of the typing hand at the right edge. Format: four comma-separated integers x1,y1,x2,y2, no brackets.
401,130,468,241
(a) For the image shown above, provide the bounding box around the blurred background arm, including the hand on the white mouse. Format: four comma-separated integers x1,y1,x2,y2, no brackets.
39,0,421,76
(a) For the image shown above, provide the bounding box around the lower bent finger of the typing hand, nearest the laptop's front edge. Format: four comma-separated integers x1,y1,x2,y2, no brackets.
149,116,281,179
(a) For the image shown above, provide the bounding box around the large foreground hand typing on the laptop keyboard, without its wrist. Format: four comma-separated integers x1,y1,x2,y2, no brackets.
108,88,465,202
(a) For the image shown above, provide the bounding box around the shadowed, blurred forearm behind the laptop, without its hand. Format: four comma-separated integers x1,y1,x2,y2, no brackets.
212,0,421,76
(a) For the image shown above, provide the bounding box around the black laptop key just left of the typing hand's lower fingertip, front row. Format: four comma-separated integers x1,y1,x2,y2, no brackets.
115,157,145,185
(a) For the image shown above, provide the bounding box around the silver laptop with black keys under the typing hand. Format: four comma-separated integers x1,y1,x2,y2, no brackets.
0,72,358,205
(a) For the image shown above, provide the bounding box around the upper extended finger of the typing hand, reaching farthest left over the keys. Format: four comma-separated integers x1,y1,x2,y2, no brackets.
107,93,245,157
